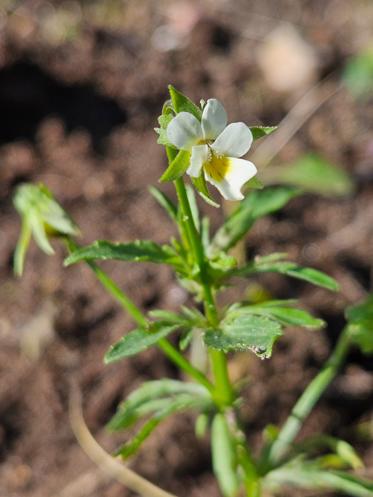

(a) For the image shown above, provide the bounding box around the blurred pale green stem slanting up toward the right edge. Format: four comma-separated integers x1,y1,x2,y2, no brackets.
268,327,350,467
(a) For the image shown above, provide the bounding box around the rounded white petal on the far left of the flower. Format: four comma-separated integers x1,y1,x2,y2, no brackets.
167,112,203,151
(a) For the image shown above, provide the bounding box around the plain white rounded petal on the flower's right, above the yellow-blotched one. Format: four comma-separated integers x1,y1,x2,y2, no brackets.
211,123,253,157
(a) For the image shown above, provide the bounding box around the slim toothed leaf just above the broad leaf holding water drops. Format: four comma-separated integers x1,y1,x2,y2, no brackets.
229,300,325,329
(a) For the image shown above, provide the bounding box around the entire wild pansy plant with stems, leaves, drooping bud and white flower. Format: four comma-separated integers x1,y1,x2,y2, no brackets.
15,86,373,497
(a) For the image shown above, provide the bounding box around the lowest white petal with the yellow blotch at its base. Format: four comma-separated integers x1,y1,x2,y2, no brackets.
205,157,257,200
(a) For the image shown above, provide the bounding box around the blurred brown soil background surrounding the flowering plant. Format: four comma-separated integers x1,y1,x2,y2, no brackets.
0,0,373,497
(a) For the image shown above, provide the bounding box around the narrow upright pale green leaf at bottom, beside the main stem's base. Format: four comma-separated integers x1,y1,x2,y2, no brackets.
211,413,239,497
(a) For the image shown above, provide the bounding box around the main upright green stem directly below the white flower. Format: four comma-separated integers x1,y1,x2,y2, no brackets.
175,178,235,407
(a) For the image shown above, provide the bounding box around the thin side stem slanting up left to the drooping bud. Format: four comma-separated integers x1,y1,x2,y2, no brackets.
65,237,215,393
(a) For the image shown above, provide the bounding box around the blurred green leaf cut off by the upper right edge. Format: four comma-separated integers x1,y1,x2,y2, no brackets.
343,47,373,98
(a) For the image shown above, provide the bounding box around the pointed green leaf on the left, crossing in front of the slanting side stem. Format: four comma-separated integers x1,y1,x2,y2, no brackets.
104,325,178,364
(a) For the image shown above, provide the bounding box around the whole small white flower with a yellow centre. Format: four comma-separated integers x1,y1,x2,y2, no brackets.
167,98,257,200
